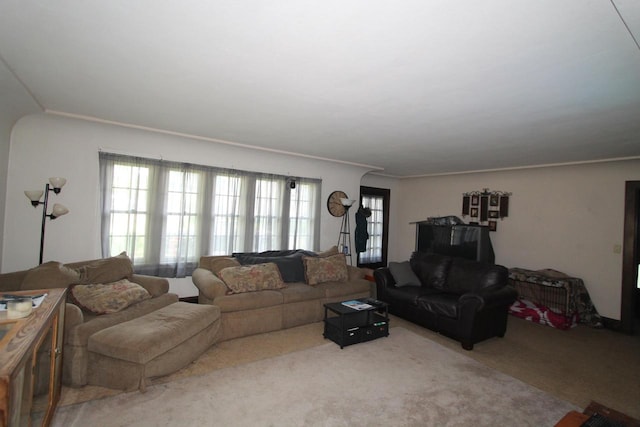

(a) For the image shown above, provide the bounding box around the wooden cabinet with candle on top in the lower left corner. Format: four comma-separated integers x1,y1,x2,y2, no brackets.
0,289,66,427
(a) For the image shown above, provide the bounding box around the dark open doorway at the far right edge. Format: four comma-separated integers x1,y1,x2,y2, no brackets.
620,181,640,334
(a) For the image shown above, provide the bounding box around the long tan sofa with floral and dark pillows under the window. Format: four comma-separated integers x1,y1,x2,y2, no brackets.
192,247,372,341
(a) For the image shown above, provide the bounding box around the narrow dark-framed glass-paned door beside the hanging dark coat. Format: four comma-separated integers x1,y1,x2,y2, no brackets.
358,187,390,268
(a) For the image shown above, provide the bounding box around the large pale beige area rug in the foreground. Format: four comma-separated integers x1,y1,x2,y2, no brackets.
53,327,578,426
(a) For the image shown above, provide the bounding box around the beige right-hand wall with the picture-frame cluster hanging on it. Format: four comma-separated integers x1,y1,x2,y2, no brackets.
389,160,640,319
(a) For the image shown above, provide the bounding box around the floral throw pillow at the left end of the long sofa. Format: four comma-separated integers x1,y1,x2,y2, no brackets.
218,262,287,294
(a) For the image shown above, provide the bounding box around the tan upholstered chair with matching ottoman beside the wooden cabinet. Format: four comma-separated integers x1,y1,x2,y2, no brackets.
0,253,220,390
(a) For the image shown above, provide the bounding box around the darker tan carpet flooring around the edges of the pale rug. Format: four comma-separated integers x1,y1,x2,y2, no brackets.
60,316,640,418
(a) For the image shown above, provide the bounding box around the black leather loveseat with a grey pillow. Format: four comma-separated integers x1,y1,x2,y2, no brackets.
374,252,517,350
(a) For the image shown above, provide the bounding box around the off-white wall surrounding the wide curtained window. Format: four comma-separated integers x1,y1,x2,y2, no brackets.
0,114,369,272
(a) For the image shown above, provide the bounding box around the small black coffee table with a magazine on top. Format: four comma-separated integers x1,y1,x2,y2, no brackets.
323,298,389,348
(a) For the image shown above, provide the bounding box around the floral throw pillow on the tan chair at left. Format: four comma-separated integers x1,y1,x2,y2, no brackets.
69,279,151,314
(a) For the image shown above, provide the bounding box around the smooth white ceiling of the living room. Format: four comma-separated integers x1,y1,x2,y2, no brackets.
0,0,640,176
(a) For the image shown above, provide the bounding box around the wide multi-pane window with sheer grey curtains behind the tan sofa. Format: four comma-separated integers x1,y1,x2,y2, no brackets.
99,152,321,277
